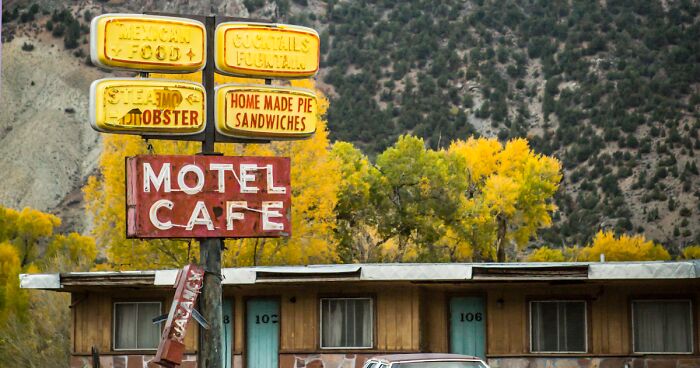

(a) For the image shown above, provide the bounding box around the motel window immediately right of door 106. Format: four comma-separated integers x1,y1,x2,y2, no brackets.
530,300,587,353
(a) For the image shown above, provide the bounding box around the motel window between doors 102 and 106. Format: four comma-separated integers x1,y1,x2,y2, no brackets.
321,298,373,348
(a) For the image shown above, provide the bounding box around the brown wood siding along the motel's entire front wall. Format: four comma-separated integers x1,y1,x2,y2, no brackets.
72,280,700,357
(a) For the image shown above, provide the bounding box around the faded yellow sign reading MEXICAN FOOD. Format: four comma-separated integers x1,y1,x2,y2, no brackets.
90,14,206,73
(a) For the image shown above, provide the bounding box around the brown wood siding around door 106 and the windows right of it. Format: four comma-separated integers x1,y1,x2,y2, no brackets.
422,280,700,357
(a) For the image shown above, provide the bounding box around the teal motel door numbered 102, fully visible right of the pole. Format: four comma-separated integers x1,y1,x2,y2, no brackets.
246,299,280,368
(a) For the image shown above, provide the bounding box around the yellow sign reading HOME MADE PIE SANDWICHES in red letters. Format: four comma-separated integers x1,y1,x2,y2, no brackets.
216,84,318,139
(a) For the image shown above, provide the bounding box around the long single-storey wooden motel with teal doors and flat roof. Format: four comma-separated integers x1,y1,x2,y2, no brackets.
20,261,700,368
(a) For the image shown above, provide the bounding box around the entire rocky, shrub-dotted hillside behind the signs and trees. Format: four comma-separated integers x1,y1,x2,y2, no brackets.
0,0,700,252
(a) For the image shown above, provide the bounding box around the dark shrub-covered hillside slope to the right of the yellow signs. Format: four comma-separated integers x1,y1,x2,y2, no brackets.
311,0,700,249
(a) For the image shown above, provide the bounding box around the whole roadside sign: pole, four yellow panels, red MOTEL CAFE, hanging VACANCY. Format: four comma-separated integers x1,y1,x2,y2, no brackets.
90,14,320,368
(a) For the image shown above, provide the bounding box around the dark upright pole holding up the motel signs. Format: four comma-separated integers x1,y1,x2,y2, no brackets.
197,16,224,368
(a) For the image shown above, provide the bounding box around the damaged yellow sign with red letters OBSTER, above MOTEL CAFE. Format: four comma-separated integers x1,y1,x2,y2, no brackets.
90,78,206,135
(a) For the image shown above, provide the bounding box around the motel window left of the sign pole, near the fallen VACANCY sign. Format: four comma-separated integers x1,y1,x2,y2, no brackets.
114,302,161,350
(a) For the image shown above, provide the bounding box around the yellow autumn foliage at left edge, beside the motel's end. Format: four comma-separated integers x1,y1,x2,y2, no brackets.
0,206,97,367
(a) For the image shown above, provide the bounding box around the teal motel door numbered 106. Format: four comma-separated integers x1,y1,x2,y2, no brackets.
450,297,486,358
